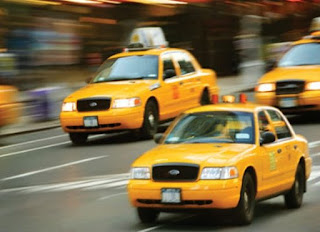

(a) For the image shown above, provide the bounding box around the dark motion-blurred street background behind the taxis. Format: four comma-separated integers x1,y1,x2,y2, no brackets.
0,0,320,129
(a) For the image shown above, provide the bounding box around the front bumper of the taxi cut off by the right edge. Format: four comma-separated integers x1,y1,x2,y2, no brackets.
255,91,320,113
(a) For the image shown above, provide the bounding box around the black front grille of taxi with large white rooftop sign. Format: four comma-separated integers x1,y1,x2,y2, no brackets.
77,98,111,112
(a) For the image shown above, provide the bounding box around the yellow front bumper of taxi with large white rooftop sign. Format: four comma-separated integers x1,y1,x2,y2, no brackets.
60,107,144,133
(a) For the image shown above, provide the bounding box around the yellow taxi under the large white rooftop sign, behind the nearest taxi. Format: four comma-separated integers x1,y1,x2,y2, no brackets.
60,47,218,144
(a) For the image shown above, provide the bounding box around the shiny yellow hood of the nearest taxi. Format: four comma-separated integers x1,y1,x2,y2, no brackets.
133,144,255,166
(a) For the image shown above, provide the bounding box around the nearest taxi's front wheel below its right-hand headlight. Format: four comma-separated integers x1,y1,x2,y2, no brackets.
234,172,256,225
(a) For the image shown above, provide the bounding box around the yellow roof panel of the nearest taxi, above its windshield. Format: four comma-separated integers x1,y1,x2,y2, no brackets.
185,102,263,114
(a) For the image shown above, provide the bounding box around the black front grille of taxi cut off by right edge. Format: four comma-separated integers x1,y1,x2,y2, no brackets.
276,80,305,95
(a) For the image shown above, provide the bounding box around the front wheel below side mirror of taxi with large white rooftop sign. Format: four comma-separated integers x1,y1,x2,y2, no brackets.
141,100,159,139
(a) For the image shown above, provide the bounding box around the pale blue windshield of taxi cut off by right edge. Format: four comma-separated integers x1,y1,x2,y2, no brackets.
278,43,320,67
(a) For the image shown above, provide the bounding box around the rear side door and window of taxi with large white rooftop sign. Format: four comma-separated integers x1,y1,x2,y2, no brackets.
173,52,201,110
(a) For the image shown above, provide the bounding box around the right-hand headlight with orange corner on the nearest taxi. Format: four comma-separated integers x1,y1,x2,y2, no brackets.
200,167,239,180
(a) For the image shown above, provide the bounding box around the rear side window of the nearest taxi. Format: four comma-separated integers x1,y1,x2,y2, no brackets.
267,110,292,139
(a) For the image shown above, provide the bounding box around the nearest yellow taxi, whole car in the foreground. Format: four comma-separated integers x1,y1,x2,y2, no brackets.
128,96,312,224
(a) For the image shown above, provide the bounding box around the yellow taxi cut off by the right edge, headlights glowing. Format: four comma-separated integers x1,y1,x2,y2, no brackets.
255,32,320,113
